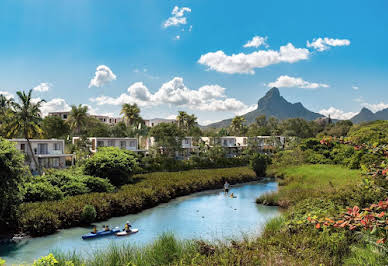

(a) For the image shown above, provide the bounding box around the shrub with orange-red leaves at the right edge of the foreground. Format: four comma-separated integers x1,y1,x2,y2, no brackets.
307,198,388,244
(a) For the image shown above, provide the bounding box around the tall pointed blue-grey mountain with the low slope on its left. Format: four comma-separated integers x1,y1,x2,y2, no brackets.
206,87,323,128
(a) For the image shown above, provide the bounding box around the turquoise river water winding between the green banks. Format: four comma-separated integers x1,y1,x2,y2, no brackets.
0,182,279,265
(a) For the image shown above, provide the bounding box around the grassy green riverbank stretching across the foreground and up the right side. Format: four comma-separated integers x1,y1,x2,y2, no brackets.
45,165,388,265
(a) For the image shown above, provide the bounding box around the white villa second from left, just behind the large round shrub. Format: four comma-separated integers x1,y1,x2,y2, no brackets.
72,137,140,153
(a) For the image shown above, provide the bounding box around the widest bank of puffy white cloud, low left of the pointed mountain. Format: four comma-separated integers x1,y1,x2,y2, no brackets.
90,77,250,113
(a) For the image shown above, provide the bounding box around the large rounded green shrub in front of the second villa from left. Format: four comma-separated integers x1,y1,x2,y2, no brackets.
84,147,139,186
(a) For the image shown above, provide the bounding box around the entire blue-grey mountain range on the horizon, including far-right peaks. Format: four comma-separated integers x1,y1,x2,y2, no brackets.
204,87,388,128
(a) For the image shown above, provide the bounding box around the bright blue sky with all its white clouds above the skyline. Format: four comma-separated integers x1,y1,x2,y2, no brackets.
0,0,388,123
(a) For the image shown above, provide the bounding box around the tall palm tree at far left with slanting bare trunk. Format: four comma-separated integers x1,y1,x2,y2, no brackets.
7,90,46,171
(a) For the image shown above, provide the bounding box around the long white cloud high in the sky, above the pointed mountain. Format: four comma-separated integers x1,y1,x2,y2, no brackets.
198,43,310,74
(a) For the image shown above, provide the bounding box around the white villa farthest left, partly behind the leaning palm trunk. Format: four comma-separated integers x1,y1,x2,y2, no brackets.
9,139,73,171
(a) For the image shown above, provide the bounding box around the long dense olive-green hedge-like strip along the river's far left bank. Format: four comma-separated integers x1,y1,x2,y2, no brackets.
19,167,258,236
